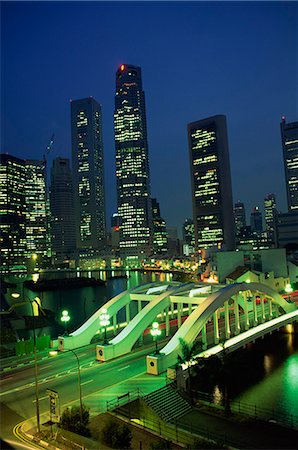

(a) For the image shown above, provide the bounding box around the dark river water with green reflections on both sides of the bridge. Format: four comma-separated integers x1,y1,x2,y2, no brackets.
12,271,298,417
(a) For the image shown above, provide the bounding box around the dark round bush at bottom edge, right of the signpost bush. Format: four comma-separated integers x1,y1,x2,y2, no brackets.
102,419,132,449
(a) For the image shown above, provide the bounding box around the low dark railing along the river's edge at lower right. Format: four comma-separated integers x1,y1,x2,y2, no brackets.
195,392,298,429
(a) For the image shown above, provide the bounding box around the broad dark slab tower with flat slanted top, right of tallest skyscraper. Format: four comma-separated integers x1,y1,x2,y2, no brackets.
188,115,235,250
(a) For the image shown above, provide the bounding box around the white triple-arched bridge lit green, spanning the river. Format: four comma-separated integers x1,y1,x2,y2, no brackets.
58,282,298,375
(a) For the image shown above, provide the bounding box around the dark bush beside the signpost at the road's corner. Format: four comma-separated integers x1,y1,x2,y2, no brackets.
59,406,91,436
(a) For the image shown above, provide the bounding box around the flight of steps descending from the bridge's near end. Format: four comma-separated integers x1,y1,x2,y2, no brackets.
142,385,191,422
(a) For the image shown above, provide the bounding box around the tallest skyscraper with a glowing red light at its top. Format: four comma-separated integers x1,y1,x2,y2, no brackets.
114,64,152,257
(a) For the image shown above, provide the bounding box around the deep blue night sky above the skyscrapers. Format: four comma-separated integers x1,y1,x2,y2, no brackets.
1,1,298,236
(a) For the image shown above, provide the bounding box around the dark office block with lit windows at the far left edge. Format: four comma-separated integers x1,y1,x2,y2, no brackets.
0,154,27,270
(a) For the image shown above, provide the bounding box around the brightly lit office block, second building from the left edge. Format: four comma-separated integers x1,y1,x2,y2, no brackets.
25,160,48,261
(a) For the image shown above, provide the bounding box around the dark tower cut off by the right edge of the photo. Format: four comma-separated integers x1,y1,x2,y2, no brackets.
280,116,298,211
